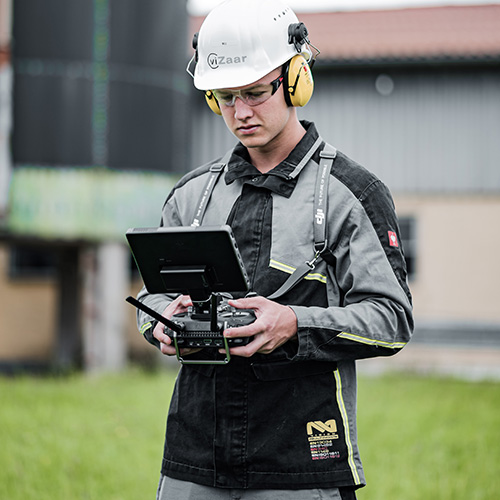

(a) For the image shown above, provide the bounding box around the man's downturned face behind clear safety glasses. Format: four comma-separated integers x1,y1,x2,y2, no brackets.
216,69,295,151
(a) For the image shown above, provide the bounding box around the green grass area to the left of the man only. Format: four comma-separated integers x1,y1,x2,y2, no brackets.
0,371,175,500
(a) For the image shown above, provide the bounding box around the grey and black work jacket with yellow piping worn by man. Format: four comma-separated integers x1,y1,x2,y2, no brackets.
138,122,413,489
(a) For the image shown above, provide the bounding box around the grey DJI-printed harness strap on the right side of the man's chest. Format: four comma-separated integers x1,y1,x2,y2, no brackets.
267,144,337,300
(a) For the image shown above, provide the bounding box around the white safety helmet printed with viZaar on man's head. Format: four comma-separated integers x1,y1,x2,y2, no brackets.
188,0,311,90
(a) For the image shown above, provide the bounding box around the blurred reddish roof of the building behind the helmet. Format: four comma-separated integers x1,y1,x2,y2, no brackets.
191,5,500,64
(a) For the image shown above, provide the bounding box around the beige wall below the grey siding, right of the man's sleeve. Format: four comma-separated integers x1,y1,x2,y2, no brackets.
396,196,500,322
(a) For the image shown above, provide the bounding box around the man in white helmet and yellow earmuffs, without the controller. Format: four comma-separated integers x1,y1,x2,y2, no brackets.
138,0,412,500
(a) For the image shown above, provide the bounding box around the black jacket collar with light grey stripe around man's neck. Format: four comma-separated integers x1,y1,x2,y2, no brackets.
225,121,321,198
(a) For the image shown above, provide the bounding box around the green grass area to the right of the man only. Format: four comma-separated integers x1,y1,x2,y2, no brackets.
358,375,500,500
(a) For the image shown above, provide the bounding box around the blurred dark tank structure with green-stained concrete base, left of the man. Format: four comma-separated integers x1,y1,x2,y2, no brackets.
0,0,190,369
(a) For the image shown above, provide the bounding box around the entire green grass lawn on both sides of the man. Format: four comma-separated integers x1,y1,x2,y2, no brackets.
0,370,500,500
